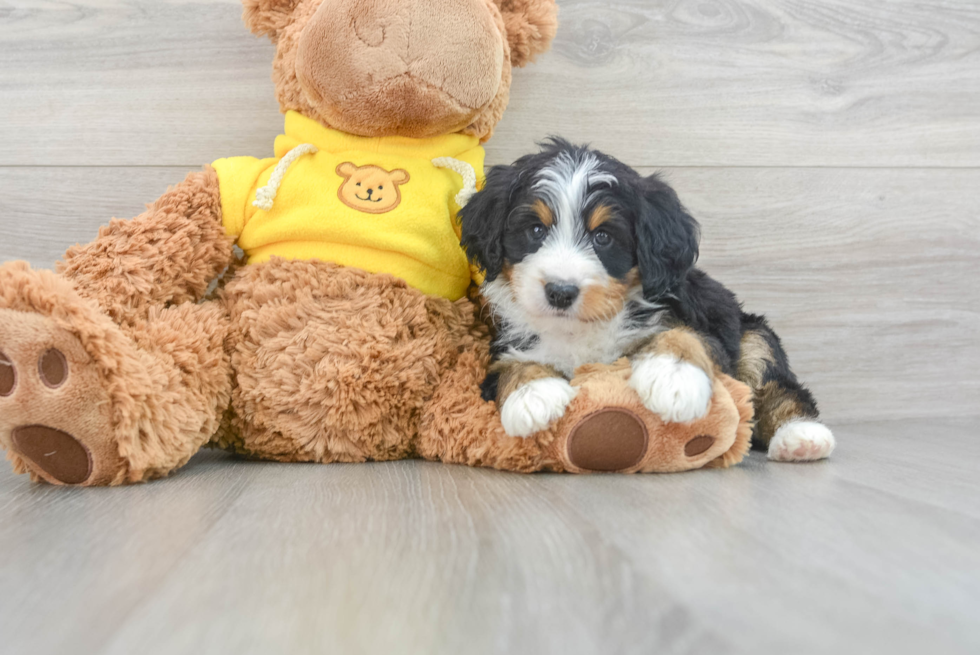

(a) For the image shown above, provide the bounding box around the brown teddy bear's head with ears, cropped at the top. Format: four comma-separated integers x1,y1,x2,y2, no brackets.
242,0,557,141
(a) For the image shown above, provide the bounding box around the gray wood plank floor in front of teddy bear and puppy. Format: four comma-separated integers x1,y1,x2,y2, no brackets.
0,419,980,655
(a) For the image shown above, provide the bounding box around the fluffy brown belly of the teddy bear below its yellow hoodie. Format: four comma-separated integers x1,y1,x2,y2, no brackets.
222,258,466,463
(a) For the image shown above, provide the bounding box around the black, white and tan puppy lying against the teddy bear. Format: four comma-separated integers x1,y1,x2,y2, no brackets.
462,139,834,461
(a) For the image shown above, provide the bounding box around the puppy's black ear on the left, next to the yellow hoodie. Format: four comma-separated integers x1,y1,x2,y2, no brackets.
459,166,518,282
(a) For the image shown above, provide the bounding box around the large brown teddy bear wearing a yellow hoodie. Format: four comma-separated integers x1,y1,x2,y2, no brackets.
0,0,751,485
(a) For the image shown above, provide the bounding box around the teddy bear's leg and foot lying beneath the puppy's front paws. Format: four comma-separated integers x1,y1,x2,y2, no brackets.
417,352,753,473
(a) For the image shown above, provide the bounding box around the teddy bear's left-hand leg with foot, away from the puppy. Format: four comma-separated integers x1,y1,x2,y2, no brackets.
0,262,231,486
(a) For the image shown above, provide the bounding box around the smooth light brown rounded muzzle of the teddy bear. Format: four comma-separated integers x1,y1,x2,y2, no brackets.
296,0,506,138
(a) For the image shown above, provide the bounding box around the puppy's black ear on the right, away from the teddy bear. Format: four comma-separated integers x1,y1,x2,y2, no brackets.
636,175,701,300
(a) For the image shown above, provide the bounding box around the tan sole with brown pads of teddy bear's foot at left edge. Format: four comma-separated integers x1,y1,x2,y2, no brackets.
0,309,123,485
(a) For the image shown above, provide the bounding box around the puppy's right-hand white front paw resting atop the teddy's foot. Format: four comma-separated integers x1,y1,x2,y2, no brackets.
630,355,712,423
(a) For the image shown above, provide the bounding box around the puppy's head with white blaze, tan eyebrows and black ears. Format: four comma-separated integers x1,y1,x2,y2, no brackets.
461,139,698,322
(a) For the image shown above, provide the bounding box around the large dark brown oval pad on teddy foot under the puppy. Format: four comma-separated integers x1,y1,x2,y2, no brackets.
566,409,649,472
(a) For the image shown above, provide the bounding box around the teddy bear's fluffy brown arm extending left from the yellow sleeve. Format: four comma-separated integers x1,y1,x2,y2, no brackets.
58,166,233,323
